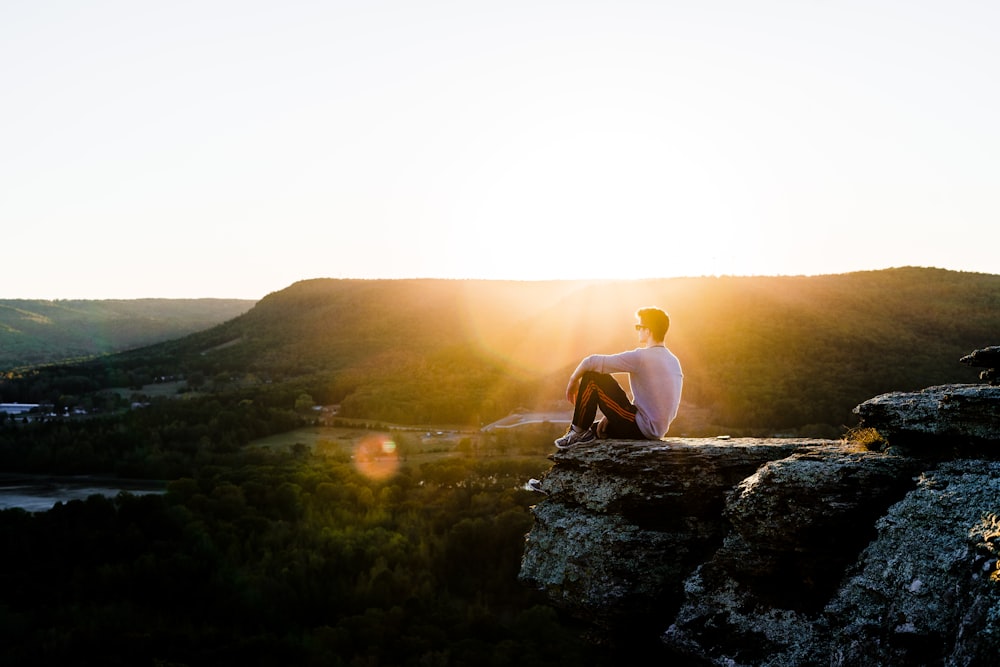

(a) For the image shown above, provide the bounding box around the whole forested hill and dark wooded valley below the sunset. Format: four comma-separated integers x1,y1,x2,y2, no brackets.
0,269,1000,667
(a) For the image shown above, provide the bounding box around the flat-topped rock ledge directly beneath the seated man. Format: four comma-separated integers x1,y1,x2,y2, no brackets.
520,438,831,630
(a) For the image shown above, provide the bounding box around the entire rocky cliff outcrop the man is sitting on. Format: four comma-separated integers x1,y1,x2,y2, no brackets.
520,385,1000,667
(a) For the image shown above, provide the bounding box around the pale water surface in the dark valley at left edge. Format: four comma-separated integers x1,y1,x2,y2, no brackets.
0,475,166,512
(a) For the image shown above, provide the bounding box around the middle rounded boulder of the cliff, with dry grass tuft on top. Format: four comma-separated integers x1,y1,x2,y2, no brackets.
663,445,919,666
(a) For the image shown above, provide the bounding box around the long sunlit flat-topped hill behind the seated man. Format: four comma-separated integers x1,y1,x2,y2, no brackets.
0,268,1000,435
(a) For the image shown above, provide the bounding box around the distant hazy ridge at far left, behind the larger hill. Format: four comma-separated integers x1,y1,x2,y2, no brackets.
0,299,254,372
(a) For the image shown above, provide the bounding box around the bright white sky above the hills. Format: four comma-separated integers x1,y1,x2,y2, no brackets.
0,0,1000,299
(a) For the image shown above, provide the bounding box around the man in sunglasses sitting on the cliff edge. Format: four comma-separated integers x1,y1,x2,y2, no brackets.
555,308,684,449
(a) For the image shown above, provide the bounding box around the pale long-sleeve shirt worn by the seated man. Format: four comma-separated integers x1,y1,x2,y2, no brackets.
573,345,684,440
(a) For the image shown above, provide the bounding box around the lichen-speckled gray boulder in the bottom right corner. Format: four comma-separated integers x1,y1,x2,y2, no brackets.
826,460,1000,667
